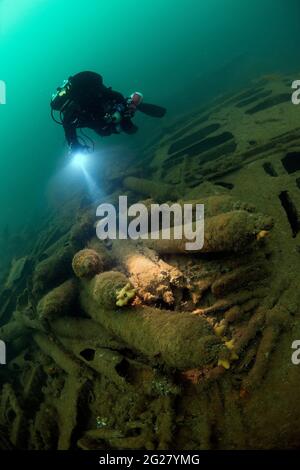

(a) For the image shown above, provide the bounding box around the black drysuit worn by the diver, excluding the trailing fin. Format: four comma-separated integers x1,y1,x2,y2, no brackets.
51,72,138,149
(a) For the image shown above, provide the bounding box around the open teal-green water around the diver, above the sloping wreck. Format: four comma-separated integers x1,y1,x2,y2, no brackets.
0,0,300,266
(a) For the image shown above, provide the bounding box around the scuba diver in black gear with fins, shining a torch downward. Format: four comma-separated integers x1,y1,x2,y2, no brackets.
51,72,166,153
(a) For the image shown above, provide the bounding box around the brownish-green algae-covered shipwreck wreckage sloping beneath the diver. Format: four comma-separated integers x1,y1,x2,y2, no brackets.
0,72,300,450
